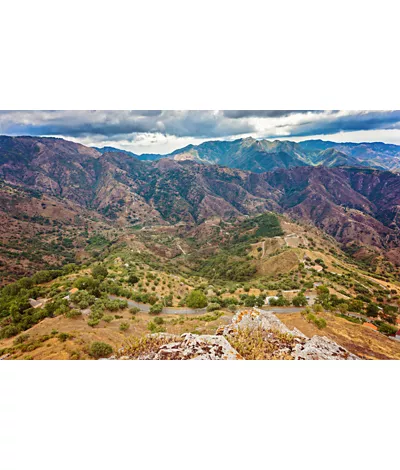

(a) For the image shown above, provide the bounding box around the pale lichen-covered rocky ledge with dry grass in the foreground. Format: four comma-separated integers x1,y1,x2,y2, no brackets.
110,308,358,360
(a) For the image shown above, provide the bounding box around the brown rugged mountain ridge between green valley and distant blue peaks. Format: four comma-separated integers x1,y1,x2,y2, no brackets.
0,137,400,276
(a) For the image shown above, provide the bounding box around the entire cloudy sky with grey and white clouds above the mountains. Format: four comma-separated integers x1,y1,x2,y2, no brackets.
0,110,400,154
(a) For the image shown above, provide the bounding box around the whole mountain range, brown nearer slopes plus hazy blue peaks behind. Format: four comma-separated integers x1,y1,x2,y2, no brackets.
0,136,400,280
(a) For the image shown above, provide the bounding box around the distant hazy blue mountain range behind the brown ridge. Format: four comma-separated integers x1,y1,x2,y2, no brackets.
97,137,400,173
